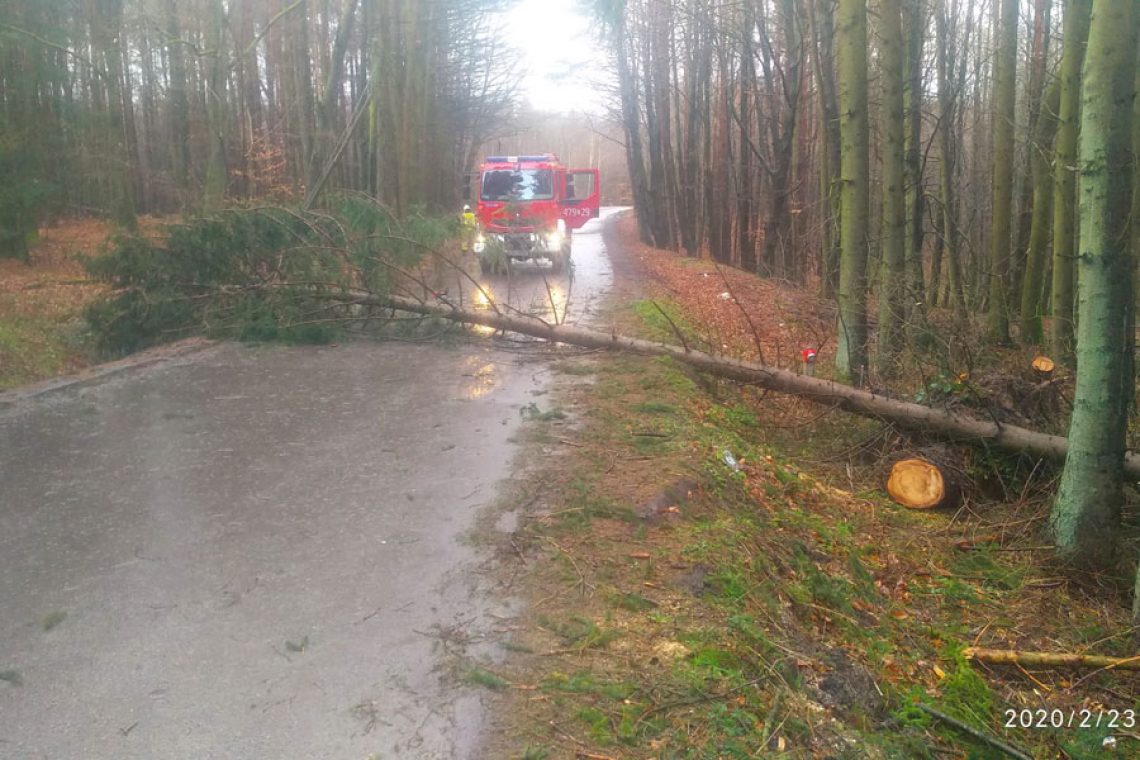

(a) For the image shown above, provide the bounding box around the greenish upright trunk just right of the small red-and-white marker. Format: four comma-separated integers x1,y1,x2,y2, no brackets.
836,0,870,385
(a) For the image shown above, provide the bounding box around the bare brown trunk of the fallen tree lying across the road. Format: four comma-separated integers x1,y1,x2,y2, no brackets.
337,294,1140,480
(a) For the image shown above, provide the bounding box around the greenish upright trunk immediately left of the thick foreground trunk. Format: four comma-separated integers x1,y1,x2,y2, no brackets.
1049,0,1092,363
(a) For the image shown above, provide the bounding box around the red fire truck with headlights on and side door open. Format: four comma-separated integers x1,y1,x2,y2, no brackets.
474,153,601,272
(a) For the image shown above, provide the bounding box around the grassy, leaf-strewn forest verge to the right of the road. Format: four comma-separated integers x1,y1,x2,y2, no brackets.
467,216,1140,760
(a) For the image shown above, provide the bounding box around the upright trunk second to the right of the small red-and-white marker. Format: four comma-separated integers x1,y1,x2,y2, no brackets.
877,0,906,374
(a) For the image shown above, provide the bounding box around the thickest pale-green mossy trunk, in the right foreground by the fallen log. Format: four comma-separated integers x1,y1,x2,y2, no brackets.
1049,0,1135,566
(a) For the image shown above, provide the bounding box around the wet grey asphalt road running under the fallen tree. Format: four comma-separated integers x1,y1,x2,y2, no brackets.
0,209,624,760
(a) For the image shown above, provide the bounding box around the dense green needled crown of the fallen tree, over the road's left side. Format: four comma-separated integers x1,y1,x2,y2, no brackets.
86,195,457,354
